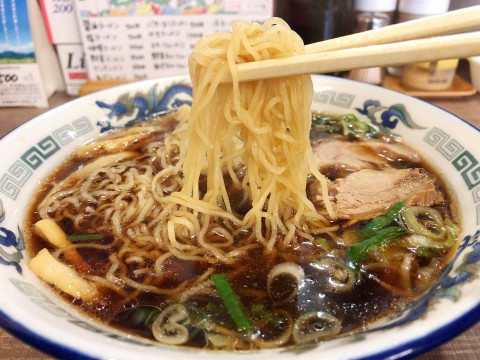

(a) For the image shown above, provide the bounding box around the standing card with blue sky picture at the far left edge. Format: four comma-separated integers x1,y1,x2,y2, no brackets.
0,0,63,107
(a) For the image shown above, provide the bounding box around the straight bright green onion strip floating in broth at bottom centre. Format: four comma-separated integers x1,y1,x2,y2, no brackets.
212,273,253,331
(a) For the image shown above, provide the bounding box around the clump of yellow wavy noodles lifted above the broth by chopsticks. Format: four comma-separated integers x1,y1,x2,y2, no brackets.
164,18,333,256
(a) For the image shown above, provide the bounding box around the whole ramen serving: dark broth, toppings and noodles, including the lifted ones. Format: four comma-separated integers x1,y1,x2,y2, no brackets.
27,18,458,350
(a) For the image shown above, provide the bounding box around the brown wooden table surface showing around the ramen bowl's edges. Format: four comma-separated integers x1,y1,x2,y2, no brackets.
0,93,480,360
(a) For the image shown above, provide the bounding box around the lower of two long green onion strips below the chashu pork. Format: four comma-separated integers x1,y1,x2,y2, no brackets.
347,226,405,270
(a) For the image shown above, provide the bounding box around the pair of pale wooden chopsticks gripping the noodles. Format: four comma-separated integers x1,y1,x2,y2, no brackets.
223,5,480,82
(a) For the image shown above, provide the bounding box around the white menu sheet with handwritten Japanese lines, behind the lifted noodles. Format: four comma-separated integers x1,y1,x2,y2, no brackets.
75,0,273,80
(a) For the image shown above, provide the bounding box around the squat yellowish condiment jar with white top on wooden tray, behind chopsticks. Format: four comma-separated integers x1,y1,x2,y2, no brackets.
398,0,458,91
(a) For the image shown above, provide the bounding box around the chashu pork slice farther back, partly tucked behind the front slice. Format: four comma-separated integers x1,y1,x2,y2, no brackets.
312,138,420,178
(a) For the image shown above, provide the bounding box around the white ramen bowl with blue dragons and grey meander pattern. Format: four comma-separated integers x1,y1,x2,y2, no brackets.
0,76,480,360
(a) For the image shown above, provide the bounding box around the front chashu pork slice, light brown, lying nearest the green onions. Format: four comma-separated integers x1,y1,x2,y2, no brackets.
331,168,444,220
